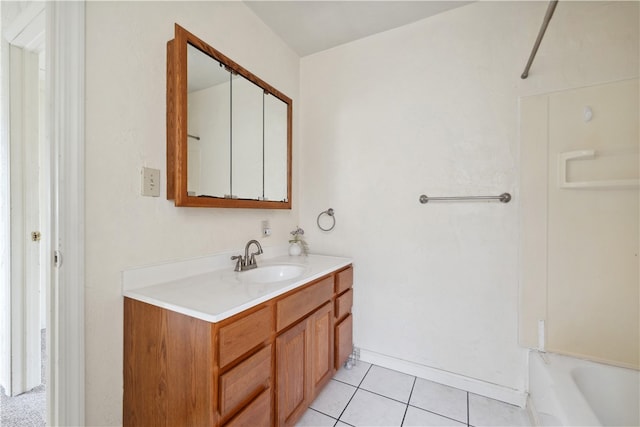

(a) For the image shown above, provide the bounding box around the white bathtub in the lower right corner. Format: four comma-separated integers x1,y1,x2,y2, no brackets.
528,351,640,426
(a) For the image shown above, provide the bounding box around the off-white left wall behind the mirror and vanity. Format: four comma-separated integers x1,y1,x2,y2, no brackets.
85,1,300,425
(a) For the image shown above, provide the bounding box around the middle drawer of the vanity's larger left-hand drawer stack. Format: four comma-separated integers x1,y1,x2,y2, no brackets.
220,345,271,418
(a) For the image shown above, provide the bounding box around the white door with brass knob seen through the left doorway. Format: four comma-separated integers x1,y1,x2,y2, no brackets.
7,45,42,396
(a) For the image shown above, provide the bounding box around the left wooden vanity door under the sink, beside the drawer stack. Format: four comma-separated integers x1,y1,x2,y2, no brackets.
276,320,312,426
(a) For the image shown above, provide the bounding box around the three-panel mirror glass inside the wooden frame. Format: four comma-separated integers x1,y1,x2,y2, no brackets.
187,44,288,201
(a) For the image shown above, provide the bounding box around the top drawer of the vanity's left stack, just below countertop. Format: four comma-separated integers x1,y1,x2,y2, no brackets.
219,306,272,368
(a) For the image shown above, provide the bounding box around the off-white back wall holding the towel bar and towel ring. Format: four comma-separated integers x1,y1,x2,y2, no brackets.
300,2,639,398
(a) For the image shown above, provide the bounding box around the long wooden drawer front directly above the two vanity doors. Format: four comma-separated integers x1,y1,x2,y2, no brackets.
276,276,333,331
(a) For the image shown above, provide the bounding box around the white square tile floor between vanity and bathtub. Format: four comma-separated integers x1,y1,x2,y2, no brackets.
297,362,531,427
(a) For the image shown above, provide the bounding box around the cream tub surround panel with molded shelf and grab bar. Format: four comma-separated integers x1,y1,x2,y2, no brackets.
518,78,640,369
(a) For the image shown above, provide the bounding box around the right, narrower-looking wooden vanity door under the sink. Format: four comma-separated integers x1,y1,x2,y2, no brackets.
310,303,335,398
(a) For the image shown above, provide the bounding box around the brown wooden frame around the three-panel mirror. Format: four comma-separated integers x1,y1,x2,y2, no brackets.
167,24,293,209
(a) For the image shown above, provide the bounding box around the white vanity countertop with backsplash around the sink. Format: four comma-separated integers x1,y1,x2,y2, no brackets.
122,254,352,322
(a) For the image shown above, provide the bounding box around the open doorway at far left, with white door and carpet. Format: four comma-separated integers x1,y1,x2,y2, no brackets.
0,2,47,426
